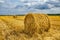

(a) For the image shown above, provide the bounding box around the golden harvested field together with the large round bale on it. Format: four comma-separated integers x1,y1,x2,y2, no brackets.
0,14,60,40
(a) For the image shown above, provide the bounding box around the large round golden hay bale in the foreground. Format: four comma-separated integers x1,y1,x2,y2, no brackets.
24,14,50,34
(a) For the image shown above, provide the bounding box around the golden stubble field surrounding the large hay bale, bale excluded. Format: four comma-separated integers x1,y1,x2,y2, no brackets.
0,16,60,40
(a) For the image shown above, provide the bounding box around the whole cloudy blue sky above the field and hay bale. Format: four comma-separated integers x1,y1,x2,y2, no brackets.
0,0,60,15
